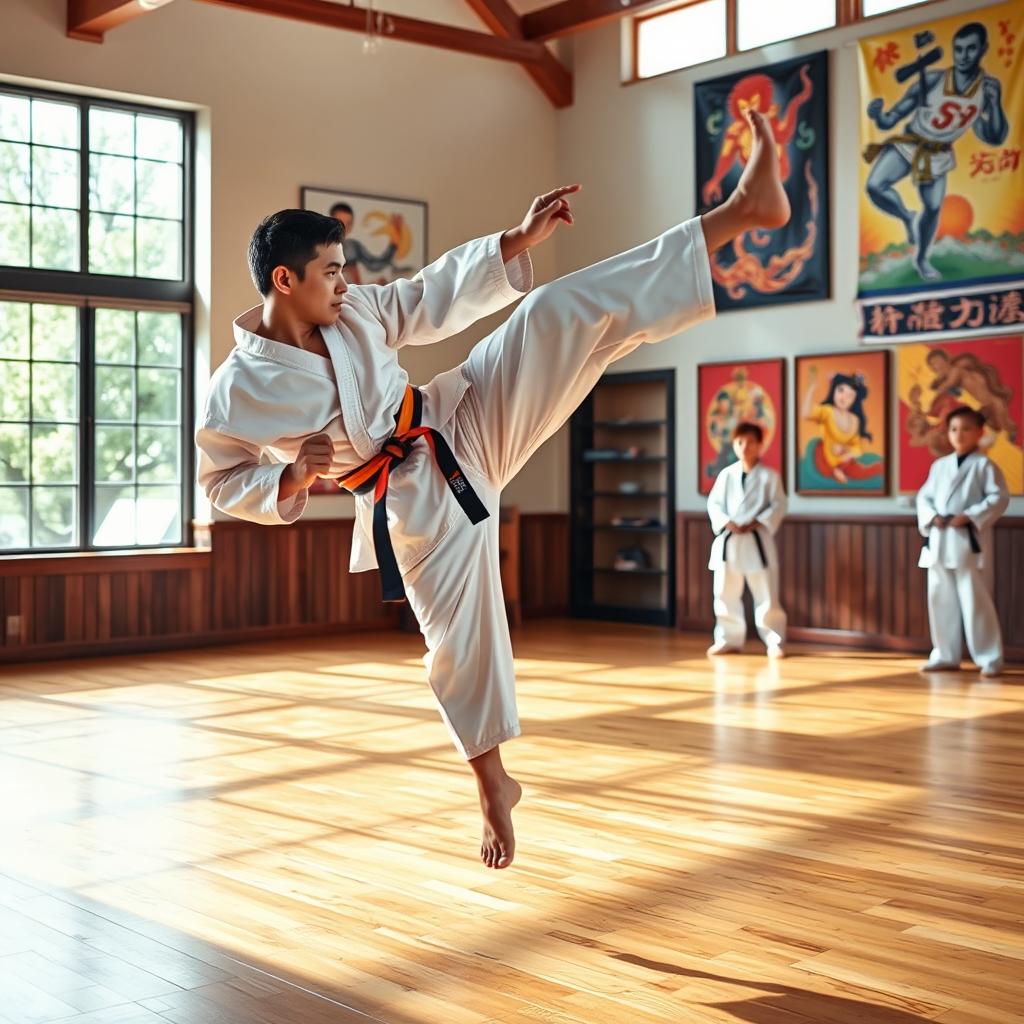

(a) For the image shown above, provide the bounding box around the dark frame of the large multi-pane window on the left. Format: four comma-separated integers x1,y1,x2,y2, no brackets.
0,80,196,559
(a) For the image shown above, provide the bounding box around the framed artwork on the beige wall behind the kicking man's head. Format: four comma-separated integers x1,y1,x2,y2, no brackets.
302,187,427,285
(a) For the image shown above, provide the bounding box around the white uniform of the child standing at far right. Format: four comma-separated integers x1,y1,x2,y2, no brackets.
918,452,1010,669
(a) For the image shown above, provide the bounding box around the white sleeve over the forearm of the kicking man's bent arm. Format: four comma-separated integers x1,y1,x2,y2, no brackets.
196,425,309,526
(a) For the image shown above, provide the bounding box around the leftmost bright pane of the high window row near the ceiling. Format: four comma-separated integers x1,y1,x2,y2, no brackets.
636,0,726,78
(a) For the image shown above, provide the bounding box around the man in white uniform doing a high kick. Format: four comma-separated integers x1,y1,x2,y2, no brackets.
196,113,790,867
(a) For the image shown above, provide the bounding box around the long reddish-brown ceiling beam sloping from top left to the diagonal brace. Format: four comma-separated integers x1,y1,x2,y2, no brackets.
200,0,550,67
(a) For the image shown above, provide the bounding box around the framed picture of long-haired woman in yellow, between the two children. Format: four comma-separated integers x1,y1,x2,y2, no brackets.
795,349,889,497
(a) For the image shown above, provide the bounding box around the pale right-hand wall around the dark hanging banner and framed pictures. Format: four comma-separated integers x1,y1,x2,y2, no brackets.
557,0,1024,516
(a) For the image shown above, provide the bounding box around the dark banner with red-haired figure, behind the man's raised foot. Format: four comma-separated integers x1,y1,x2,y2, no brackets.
694,52,829,312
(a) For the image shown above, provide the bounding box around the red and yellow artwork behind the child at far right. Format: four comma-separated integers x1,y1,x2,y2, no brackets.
896,336,1024,495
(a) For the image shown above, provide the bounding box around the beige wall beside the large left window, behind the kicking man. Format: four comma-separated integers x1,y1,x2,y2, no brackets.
0,0,569,515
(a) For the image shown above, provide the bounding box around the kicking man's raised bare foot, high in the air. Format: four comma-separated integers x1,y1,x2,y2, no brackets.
700,111,791,252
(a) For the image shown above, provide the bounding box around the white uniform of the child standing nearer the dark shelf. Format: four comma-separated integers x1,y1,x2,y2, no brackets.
708,462,785,647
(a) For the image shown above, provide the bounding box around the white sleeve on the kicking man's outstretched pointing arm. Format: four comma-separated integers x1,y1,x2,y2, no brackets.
351,234,534,348
